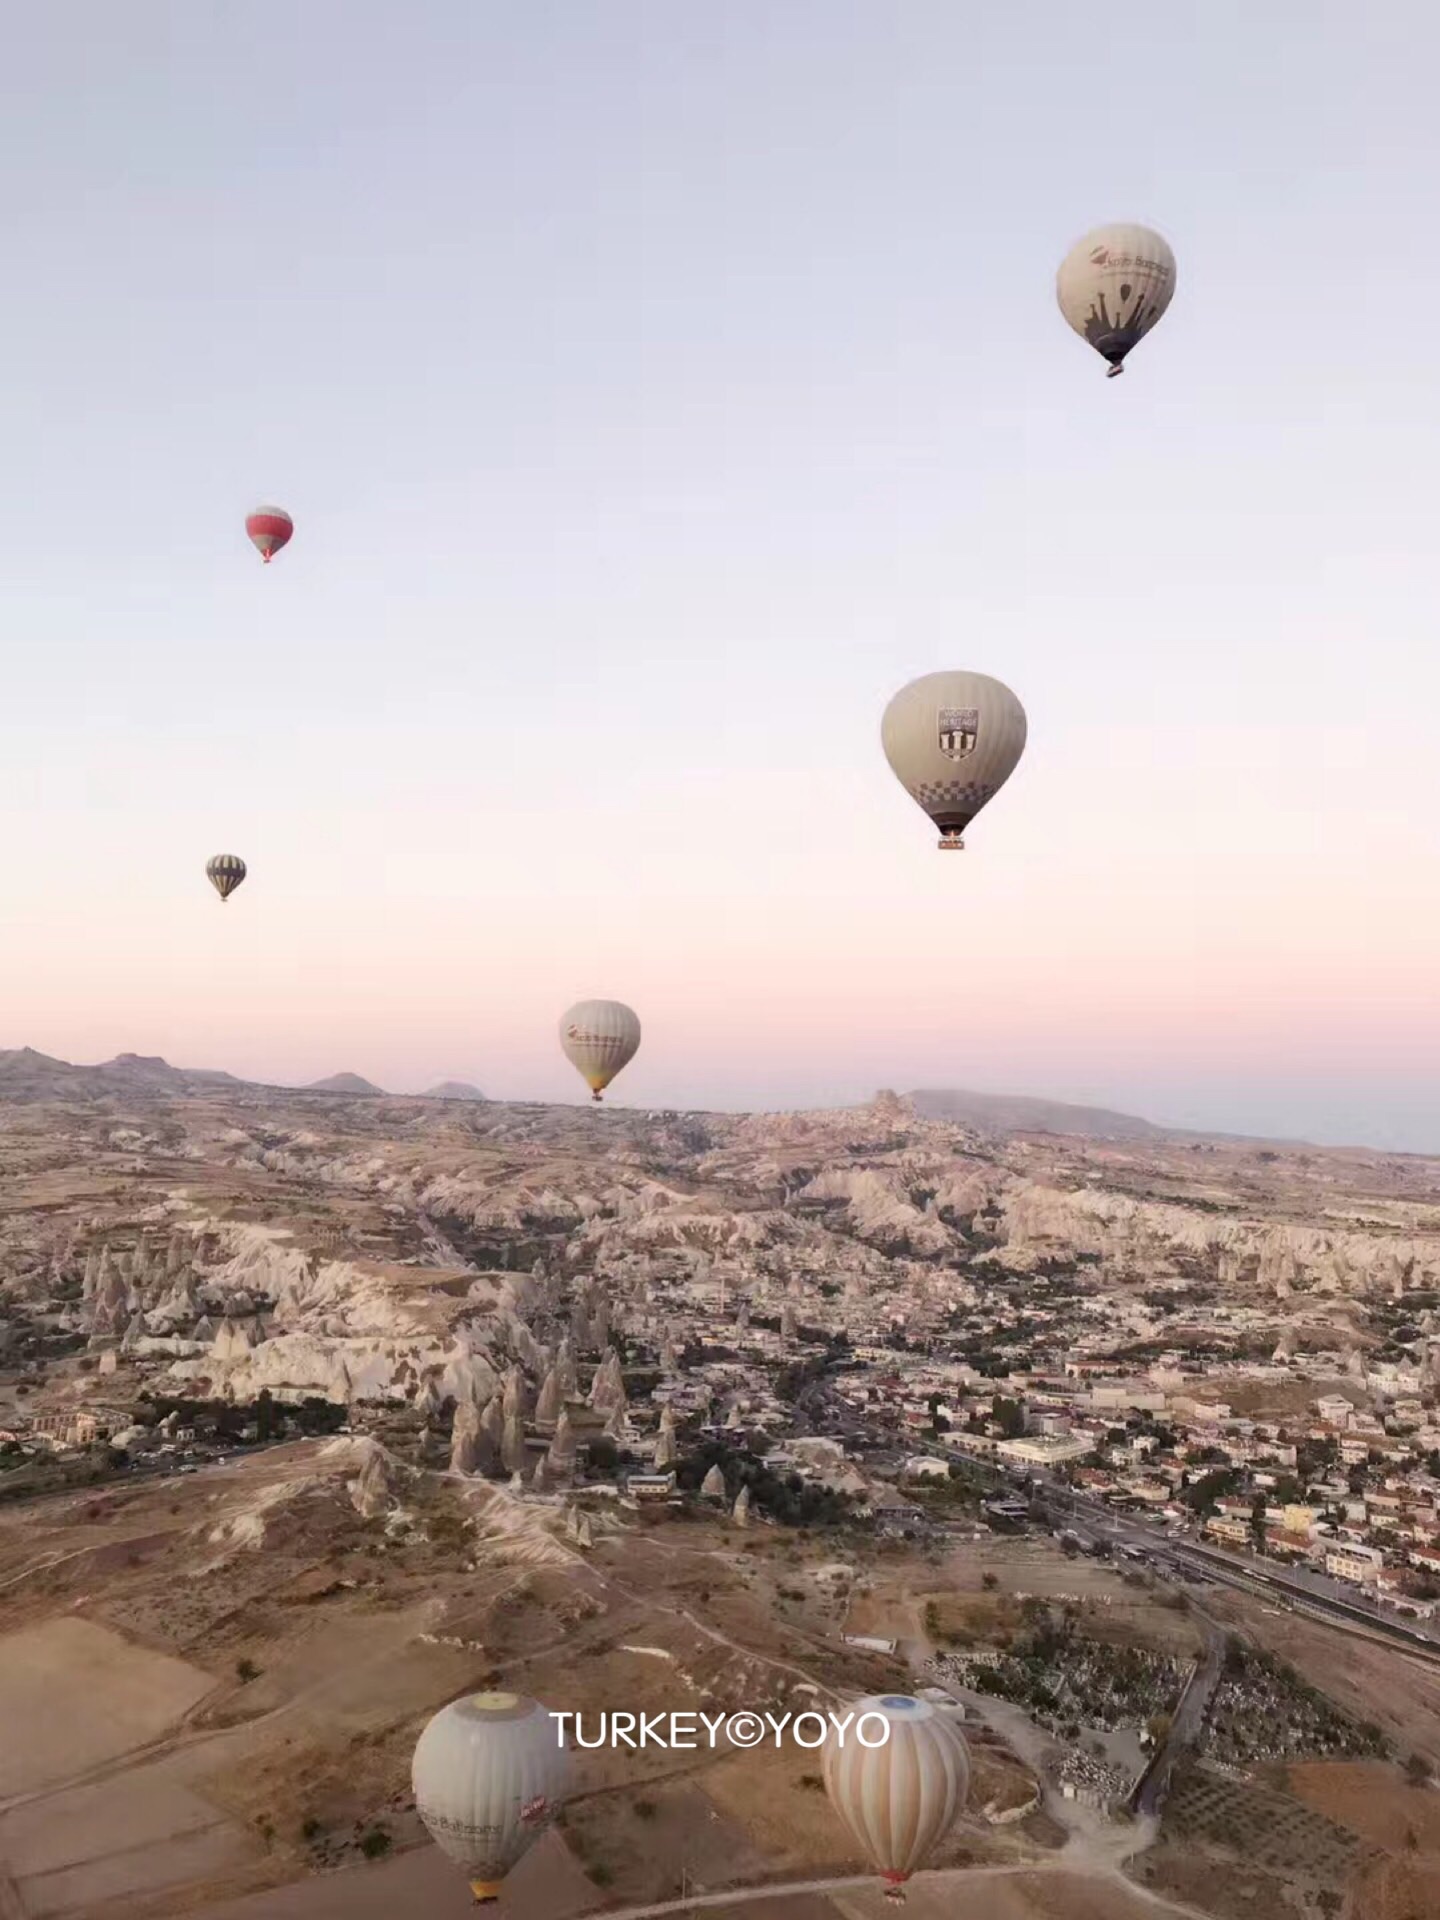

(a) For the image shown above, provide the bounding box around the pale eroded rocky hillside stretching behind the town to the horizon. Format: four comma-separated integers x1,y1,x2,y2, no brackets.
0,1090,1440,1404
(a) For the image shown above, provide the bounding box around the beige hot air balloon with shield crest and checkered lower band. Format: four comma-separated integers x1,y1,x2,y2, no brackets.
879,674,1025,849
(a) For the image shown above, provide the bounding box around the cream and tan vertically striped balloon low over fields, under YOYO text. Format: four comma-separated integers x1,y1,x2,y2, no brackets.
822,1693,970,1901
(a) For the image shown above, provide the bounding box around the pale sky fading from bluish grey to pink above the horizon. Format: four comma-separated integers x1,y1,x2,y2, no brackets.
0,0,1440,1150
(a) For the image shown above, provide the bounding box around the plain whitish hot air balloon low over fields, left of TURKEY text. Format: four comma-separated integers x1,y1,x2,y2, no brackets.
411,1693,570,1901
